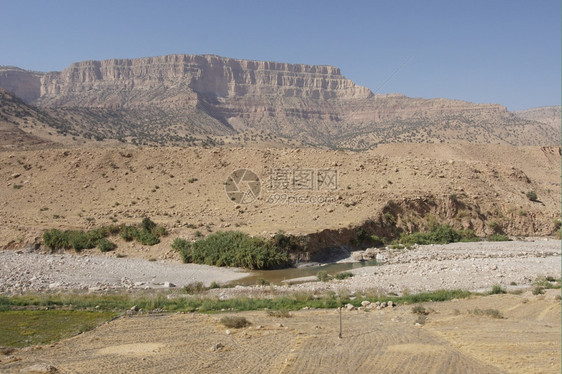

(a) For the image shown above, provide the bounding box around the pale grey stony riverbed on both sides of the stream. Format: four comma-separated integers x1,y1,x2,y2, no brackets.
0,239,561,297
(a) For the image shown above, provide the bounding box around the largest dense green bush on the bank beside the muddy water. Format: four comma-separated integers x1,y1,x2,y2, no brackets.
172,231,289,270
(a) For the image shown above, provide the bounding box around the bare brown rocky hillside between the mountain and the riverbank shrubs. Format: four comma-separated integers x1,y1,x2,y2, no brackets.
0,144,560,254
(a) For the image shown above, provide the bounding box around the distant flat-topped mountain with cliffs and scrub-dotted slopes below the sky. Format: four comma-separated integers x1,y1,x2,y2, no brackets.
0,55,559,150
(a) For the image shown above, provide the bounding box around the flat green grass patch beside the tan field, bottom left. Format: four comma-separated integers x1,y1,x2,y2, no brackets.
0,310,116,347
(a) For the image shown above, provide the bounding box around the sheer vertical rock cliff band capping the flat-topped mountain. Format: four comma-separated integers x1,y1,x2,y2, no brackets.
37,55,371,107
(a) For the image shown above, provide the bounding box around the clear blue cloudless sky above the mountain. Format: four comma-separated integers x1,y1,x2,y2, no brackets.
0,0,561,110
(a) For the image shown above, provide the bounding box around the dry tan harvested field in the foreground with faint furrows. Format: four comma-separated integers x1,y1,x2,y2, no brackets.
0,290,561,374
